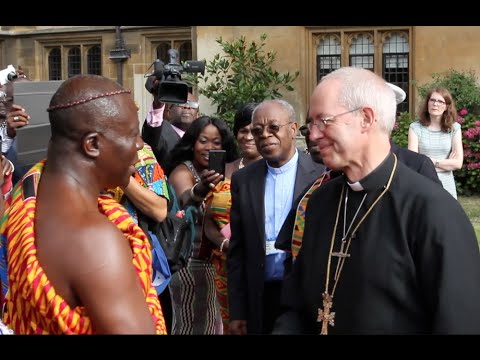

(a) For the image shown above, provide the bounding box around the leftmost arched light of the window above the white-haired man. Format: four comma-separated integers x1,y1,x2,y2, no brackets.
317,34,342,82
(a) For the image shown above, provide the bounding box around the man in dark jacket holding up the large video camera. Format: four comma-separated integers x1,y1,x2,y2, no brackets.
142,75,199,169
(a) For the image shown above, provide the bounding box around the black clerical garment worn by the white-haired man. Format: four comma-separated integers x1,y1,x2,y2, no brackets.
274,154,480,334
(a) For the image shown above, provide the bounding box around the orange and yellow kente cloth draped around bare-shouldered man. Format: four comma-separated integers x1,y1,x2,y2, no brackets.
0,160,166,334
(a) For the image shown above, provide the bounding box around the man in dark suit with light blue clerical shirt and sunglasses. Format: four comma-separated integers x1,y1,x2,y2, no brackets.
227,100,325,335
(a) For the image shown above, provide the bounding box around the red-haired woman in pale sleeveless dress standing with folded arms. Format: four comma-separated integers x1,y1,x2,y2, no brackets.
408,87,463,199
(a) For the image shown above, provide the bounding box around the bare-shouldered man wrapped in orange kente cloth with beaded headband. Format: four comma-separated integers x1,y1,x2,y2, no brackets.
0,75,165,334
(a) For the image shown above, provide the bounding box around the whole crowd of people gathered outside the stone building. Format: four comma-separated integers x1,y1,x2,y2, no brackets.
0,67,480,335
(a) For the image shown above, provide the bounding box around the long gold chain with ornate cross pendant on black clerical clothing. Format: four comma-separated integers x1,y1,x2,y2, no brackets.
317,154,397,335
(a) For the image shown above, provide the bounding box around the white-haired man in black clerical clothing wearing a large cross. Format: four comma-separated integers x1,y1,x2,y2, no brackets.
273,68,480,334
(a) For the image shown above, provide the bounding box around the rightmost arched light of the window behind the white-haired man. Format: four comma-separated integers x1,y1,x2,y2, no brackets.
382,32,409,112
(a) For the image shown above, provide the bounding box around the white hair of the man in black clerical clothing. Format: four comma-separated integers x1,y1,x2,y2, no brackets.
320,67,397,134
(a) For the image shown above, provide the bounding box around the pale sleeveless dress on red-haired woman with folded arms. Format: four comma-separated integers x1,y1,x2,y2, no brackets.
410,121,460,199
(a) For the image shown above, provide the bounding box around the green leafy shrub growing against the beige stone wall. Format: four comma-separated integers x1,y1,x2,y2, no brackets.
186,34,299,126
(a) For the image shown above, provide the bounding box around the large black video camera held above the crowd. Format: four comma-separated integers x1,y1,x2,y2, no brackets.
145,49,205,104
